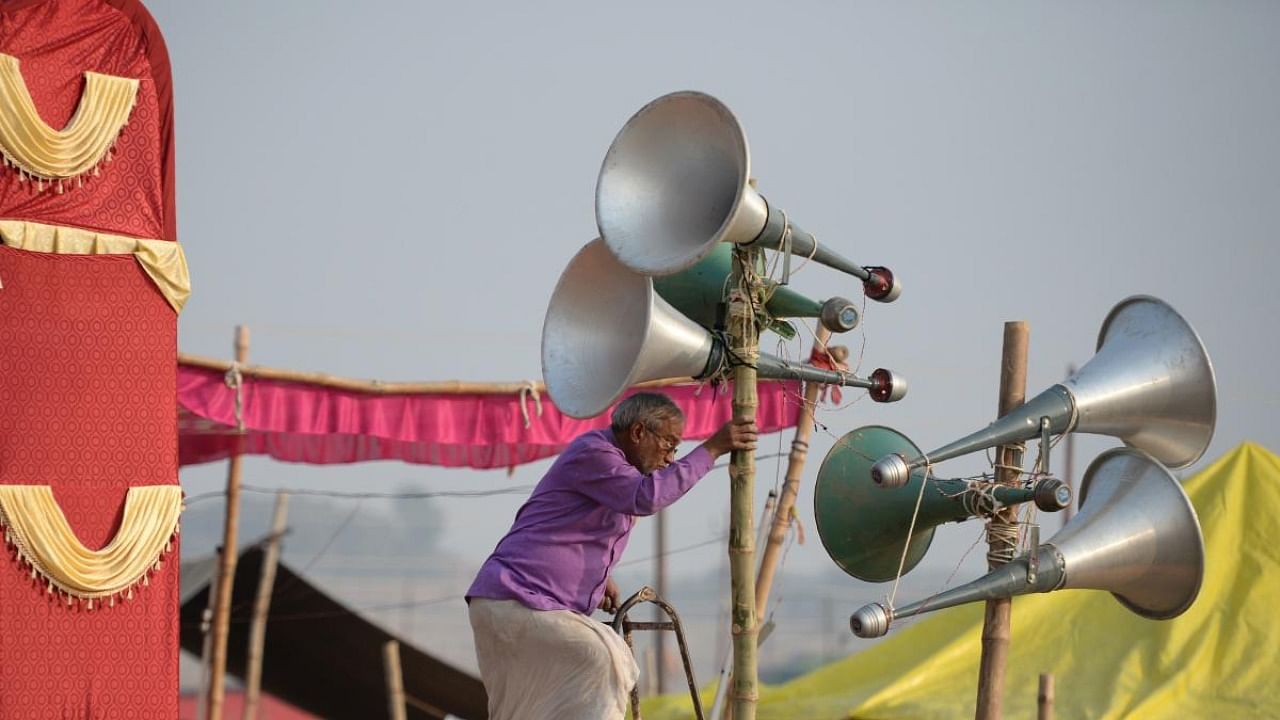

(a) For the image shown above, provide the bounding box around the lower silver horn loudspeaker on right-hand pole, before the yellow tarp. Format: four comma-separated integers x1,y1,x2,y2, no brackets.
849,447,1204,638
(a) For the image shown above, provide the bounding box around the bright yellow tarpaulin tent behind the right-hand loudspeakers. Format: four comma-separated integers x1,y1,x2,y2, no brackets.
643,443,1280,720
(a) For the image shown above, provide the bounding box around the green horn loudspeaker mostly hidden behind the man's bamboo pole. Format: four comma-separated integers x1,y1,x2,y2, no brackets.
653,243,858,333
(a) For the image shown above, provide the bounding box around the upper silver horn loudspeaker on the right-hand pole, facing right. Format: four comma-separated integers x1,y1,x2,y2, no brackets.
872,295,1217,487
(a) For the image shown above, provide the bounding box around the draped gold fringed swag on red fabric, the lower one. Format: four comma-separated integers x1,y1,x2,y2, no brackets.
0,486,182,610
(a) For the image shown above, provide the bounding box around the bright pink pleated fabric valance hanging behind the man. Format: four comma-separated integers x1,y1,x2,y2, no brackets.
178,365,803,469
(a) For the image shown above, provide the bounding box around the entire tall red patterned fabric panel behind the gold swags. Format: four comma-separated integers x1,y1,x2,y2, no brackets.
0,0,179,720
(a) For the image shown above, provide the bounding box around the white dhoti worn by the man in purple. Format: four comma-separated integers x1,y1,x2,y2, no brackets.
470,598,640,720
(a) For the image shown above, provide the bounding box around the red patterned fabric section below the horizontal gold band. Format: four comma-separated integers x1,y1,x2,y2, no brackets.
0,247,178,720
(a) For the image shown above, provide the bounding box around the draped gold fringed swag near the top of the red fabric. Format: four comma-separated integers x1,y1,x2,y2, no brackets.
0,53,138,190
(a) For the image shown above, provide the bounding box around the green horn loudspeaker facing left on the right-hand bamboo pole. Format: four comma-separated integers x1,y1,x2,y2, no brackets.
813,425,1071,583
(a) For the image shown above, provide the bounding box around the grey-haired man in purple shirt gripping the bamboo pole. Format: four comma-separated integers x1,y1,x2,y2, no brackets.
467,393,756,720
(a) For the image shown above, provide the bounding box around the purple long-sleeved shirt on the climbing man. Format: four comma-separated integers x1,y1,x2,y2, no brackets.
467,429,712,615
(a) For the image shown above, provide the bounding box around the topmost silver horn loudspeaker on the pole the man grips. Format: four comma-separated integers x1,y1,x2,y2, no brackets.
595,92,902,302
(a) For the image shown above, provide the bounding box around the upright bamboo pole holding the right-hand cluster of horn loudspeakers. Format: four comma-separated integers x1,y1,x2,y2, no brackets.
975,322,1030,720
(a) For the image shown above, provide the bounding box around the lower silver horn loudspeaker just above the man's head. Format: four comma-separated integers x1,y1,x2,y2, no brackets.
543,240,906,418
